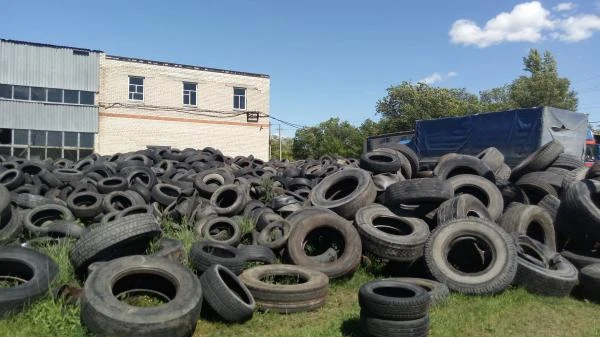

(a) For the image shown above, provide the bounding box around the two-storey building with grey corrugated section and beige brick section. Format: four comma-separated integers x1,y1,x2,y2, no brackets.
0,40,270,160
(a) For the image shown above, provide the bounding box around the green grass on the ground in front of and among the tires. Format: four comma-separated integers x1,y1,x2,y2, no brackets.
0,221,600,337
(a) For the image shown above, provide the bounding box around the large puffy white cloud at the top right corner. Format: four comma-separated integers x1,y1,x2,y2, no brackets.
449,1,600,48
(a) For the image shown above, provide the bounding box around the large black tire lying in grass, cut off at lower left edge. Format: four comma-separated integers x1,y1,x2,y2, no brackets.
0,246,58,317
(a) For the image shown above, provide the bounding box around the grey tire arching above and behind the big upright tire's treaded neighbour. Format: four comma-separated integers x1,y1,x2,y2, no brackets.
446,174,504,221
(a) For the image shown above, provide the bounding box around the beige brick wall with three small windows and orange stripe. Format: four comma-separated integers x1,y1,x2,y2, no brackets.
96,54,270,160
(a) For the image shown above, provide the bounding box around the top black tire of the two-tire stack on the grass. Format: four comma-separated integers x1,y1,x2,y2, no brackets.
358,279,430,321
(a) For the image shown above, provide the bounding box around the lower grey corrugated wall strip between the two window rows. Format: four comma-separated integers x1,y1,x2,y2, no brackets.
0,100,98,132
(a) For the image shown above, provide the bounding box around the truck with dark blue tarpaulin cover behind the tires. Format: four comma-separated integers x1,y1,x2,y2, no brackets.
364,106,598,167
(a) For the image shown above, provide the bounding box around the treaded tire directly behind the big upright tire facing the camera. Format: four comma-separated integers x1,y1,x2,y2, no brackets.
436,194,493,226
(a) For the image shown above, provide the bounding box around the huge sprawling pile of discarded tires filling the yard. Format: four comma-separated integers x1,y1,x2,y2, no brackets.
0,141,600,336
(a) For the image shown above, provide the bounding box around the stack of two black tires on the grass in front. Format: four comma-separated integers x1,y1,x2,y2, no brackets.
358,279,430,337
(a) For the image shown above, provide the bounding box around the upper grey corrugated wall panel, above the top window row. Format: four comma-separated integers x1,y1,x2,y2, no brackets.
0,41,100,92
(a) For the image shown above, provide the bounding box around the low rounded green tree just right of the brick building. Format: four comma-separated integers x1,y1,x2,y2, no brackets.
292,118,364,159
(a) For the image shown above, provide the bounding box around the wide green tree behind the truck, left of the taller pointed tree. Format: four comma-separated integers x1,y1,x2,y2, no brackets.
376,81,481,131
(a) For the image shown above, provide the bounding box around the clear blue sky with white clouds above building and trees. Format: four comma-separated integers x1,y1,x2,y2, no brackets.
0,0,600,135
